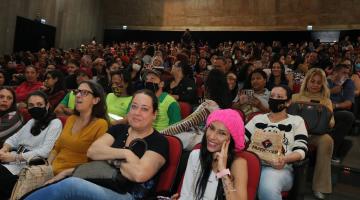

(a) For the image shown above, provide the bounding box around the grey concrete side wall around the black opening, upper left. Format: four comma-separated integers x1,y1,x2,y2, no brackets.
0,0,104,55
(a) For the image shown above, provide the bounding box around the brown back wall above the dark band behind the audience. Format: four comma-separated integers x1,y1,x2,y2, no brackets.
104,0,360,31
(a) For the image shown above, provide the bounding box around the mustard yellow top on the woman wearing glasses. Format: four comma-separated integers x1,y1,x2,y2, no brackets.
52,115,108,175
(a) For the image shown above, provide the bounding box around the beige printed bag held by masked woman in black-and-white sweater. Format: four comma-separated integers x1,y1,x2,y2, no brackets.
247,130,284,165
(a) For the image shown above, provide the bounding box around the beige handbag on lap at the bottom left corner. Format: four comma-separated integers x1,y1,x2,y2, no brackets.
10,157,54,200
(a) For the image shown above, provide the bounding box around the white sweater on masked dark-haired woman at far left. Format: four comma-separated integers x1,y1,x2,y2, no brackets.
4,119,62,174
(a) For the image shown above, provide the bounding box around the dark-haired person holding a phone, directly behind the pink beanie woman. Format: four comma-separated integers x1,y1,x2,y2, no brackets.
233,69,270,119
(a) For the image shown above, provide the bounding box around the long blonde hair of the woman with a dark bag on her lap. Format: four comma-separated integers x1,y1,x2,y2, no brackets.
299,68,330,98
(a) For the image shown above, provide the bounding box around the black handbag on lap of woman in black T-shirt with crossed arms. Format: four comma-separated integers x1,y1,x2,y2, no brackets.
72,139,148,193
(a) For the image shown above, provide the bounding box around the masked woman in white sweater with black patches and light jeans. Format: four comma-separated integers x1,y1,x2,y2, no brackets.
245,85,308,200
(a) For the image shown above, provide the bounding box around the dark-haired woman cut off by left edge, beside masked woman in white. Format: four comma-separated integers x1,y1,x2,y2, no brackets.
0,87,23,147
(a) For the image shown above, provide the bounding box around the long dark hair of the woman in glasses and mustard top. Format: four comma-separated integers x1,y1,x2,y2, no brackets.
74,81,109,121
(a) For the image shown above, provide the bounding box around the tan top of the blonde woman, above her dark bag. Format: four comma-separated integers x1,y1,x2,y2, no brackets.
291,92,335,127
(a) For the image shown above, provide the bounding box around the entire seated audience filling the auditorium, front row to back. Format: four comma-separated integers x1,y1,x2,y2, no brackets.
0,34,360,200
